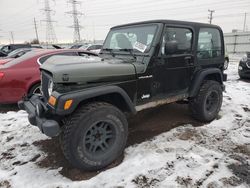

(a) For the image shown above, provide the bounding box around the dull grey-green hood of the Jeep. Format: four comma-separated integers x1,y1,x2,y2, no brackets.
41,56,141,83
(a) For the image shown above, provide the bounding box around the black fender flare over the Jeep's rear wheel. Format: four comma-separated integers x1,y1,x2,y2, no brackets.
189,68,223,97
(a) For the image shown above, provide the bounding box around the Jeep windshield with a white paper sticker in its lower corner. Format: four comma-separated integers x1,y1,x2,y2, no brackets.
103,25,157,53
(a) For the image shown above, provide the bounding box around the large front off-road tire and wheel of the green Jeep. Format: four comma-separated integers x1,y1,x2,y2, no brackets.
60,102,128,171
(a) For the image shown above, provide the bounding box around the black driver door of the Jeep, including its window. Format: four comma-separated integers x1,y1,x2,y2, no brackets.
152,26,194,97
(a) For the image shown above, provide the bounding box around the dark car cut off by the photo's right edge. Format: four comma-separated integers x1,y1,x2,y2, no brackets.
238,52,250,79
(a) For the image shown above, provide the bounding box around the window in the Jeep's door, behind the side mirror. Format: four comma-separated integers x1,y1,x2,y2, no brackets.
161,27,193,55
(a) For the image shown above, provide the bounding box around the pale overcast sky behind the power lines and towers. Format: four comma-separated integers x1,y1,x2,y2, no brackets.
0,0,250,44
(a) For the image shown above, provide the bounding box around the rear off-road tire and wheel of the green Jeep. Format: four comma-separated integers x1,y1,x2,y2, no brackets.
189,80,223,122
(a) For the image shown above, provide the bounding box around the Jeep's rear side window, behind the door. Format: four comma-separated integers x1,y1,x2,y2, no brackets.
197,28,222,59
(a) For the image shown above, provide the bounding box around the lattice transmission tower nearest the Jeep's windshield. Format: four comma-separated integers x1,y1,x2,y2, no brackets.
66,0,83,43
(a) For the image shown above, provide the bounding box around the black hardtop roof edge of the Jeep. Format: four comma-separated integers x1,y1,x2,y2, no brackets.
111,20,220,29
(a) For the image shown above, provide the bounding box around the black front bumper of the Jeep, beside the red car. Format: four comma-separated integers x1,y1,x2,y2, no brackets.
18,95,60,137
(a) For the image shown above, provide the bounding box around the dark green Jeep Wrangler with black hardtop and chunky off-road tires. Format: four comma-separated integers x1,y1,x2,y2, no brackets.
19,20,227,170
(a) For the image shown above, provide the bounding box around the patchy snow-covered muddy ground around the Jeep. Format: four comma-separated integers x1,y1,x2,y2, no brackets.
0,59,250,188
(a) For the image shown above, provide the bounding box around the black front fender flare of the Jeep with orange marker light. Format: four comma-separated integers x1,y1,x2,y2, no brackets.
53,85,136,115
